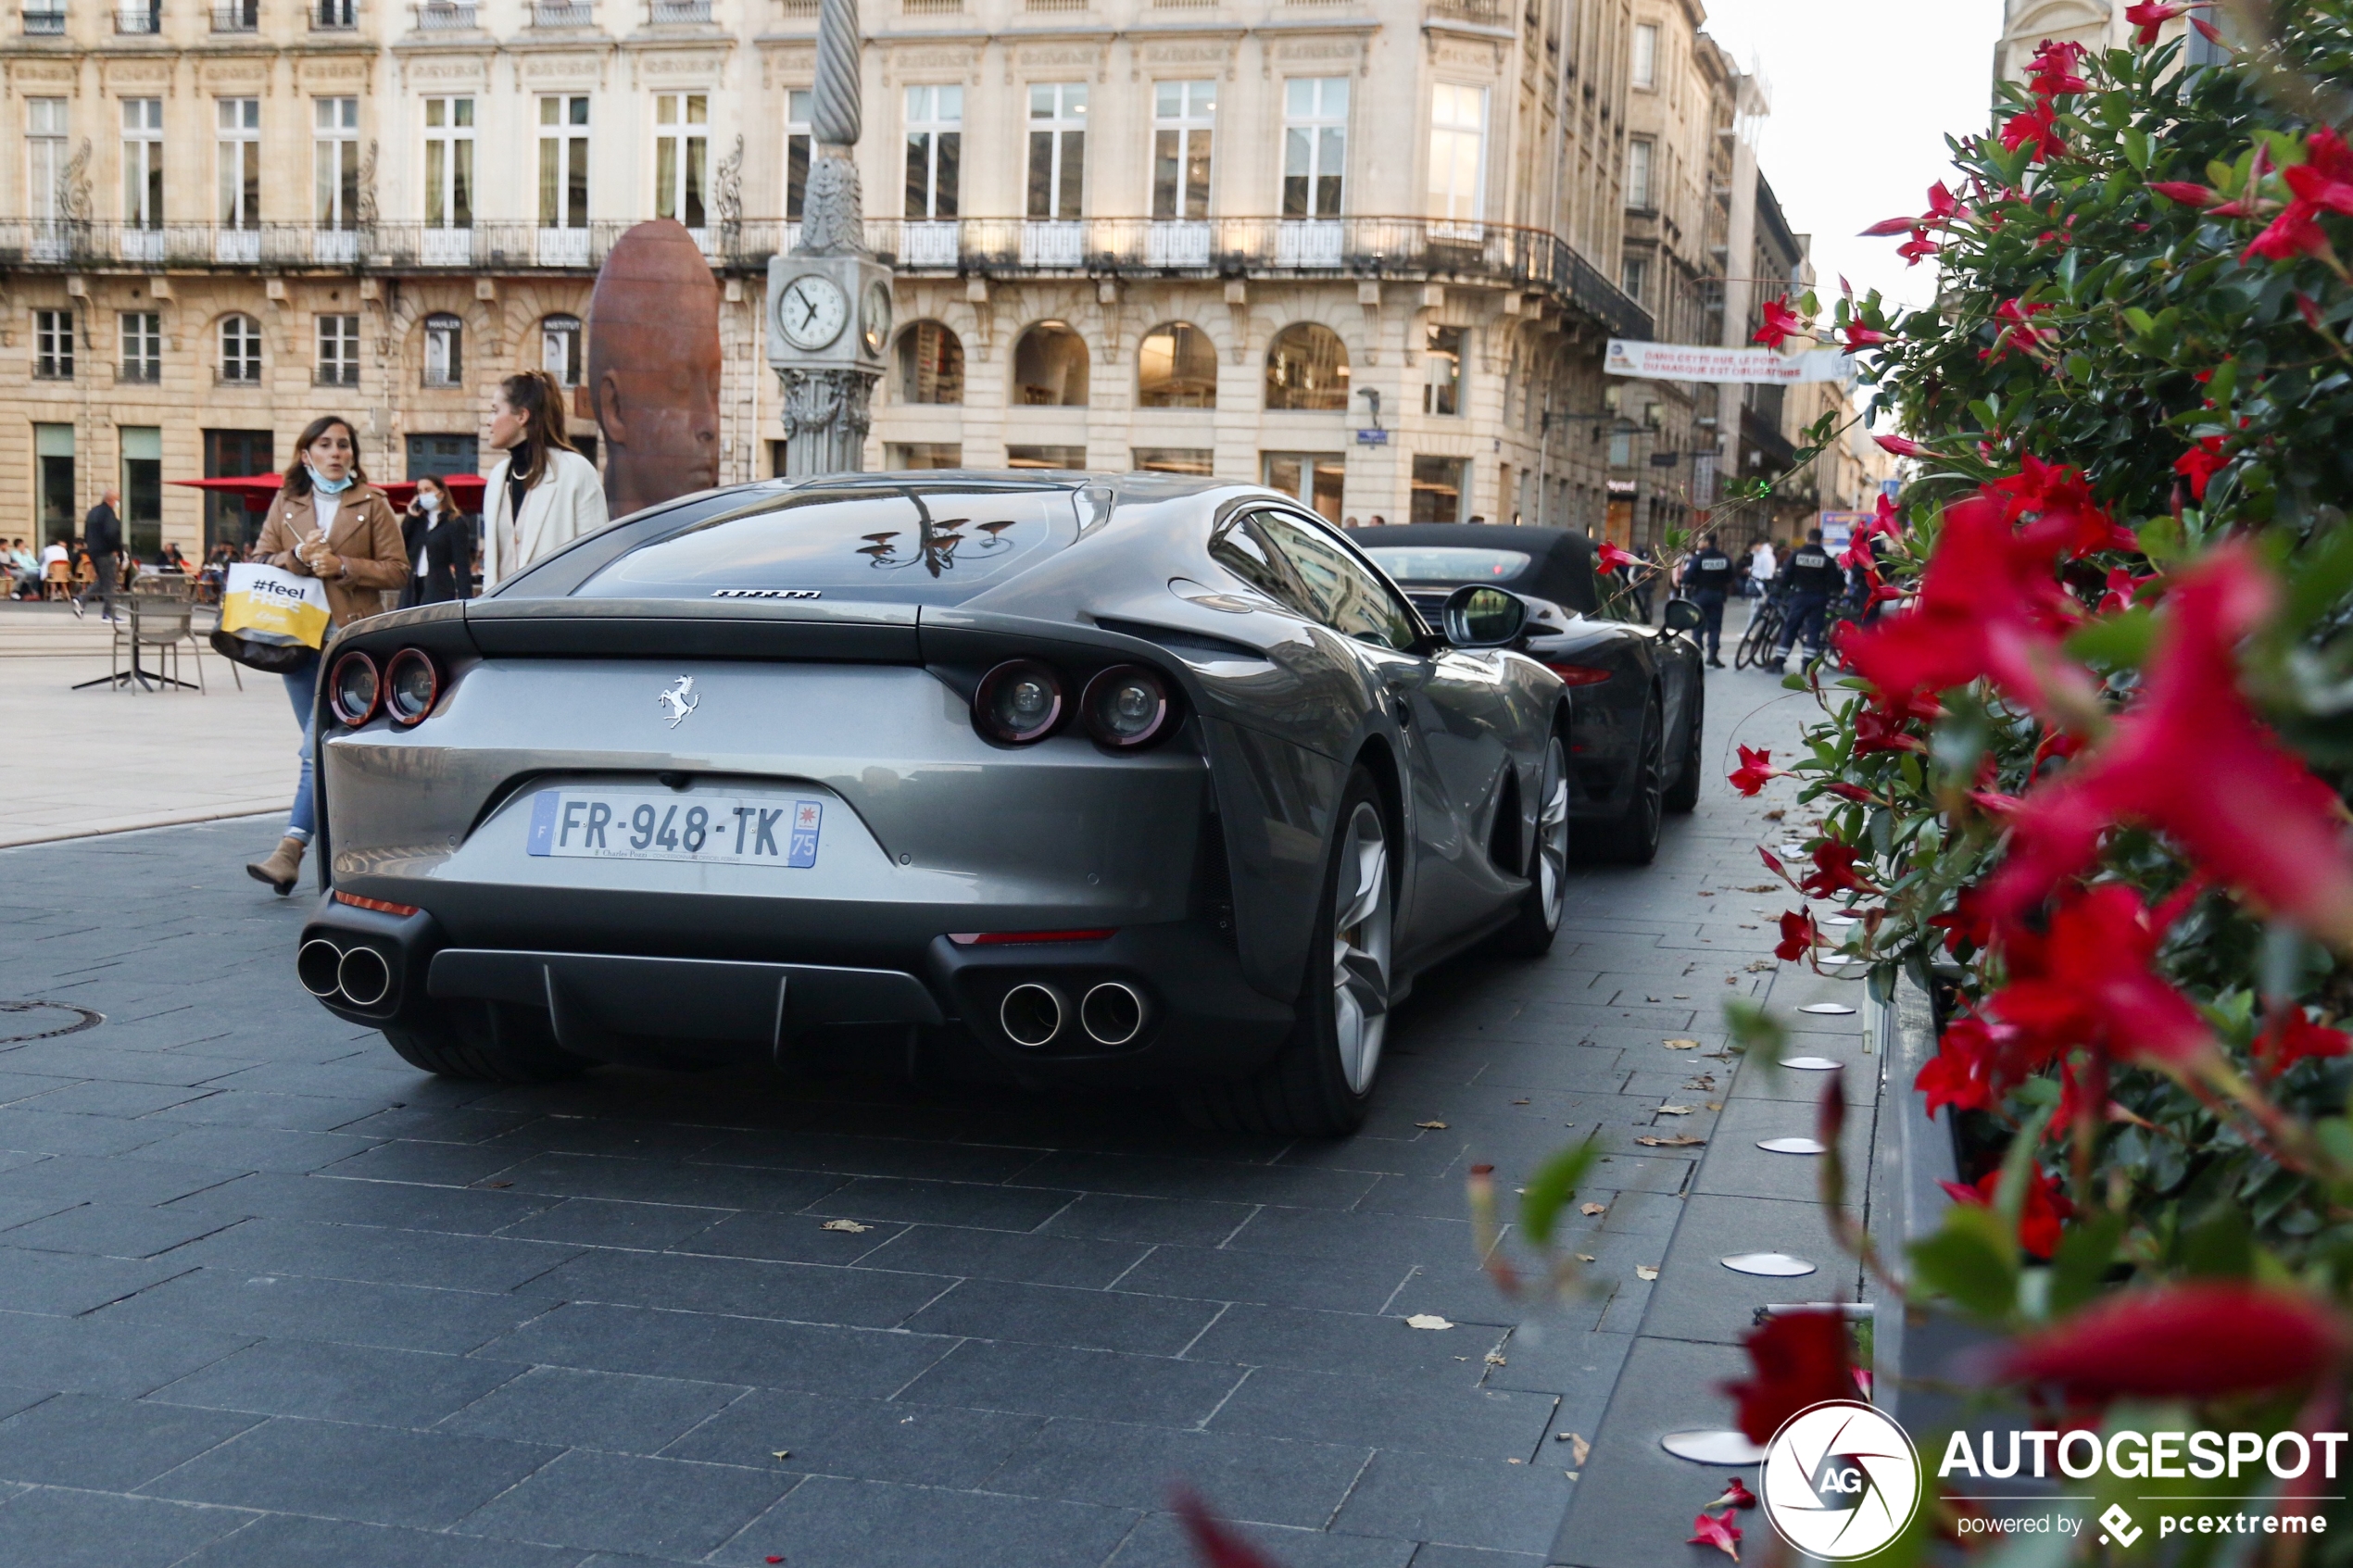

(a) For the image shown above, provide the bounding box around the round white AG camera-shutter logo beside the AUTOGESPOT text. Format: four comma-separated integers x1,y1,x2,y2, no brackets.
1757,1399,1922,1563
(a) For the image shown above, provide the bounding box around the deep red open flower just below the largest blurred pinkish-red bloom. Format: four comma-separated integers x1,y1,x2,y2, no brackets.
1986,882,2214,1067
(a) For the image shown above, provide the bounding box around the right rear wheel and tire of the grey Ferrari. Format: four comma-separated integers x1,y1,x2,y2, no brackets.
1184,766,1398,1138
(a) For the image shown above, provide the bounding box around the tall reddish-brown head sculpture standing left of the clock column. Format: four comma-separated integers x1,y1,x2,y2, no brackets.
588,219,720,517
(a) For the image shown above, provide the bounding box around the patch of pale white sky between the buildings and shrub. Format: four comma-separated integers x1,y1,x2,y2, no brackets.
1704,0,2003,306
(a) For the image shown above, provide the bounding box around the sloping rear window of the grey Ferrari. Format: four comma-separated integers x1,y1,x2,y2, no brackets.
574,484,1077,604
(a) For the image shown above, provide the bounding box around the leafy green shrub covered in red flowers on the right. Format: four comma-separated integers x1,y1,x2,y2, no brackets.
1703,0,2353,1556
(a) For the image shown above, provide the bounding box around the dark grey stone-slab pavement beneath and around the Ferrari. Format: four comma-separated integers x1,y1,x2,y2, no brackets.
0,644,1809,1568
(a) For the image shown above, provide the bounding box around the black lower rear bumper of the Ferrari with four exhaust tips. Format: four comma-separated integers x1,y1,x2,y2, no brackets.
299,896,1291,1086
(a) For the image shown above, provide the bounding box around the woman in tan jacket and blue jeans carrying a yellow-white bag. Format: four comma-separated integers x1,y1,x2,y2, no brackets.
245,414,409,896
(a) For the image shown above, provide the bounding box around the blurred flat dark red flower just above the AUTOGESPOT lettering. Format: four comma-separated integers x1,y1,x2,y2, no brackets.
1993,1279,2344,1401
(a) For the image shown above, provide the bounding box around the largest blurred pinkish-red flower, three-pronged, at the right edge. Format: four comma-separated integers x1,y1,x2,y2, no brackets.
1985,541,2353,940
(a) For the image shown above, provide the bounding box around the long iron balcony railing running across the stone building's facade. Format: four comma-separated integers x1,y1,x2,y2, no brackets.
0,217,1652,339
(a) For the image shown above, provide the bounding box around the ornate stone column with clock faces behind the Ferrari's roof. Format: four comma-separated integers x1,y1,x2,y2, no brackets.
767,0,892,480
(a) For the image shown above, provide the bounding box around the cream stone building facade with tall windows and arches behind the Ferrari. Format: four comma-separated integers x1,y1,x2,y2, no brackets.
0,0,1693,550
